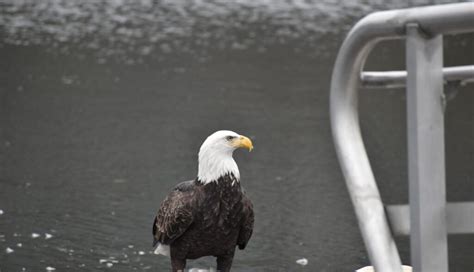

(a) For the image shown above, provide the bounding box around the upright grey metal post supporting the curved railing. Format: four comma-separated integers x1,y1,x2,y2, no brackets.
406,24,448,272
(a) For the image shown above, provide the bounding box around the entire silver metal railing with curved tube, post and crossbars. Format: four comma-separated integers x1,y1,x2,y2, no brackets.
330,2,474,272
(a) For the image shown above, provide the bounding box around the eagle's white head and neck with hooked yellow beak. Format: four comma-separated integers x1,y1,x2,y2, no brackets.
198,130,253,184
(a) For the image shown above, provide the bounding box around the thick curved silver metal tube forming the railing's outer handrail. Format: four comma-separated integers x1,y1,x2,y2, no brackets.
330,3,474,272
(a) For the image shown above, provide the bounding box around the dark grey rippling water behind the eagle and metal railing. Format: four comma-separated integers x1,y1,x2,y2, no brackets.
0,0,474,272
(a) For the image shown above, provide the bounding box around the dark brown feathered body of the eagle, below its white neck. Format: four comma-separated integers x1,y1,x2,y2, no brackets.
153,174,254,271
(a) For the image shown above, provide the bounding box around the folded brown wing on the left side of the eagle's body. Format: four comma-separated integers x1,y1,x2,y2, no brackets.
153,181,195,246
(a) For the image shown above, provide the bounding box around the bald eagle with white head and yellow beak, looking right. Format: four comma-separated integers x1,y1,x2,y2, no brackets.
153,130,254,272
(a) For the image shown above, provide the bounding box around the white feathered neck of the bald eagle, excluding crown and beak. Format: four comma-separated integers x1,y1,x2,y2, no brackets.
198,149,240,184
